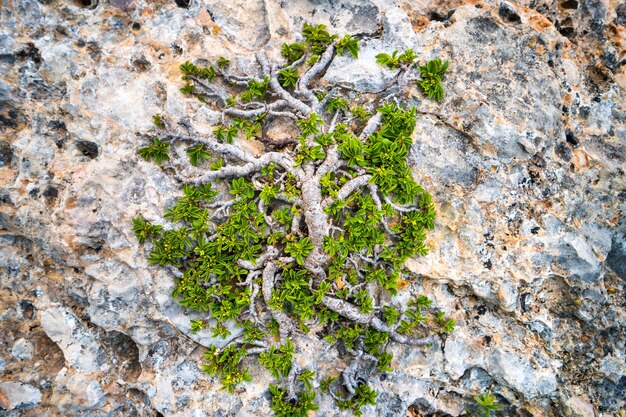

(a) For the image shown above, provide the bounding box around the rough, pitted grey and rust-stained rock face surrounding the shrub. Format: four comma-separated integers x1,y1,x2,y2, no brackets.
0,0,626,417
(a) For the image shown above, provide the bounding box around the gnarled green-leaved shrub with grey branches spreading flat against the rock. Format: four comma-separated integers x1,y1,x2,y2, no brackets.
134,24,454,416
